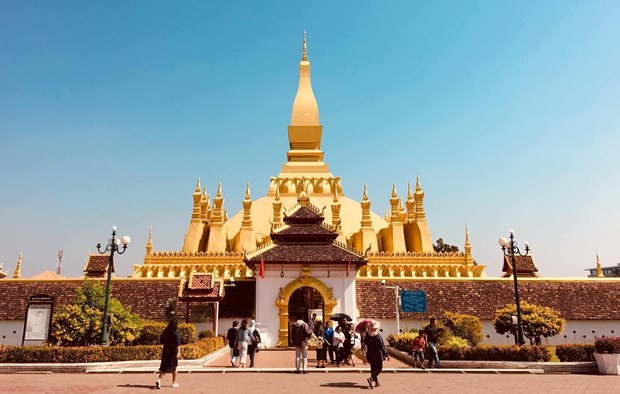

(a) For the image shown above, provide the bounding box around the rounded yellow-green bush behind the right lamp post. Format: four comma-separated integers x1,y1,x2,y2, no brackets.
493,301,566,345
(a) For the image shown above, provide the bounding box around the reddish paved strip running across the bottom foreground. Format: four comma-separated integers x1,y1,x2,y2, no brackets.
0,372,620,394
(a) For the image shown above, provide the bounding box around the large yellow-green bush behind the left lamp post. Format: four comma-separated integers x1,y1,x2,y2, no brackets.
50,279,142,346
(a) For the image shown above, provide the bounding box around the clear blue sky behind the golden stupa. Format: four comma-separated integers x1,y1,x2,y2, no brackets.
0,0,620,277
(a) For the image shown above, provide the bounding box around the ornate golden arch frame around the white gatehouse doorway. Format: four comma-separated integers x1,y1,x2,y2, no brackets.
276,266,336,347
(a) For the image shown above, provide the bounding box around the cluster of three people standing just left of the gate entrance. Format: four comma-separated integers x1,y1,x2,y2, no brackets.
226,319,261,368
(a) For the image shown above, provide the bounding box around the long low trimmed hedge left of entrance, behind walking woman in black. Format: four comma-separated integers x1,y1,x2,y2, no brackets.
0,336,224,363
